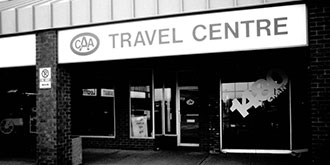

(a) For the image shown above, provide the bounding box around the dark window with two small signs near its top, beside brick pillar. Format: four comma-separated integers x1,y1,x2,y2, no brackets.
71,66,115,137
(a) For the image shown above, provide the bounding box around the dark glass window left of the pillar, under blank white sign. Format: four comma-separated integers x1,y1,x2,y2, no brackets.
0,66,37,136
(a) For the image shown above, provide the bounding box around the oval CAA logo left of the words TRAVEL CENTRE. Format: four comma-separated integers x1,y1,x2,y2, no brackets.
70,33,100,56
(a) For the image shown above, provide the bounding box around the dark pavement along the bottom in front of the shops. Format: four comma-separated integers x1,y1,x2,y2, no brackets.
0,149,309,165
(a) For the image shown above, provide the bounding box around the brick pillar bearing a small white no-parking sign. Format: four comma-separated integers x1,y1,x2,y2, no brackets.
36,31,72,165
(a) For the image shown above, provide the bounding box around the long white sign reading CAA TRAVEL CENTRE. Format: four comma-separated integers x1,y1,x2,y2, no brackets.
59,4,307,63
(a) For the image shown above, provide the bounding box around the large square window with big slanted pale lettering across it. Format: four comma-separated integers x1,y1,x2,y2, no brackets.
221,69,290,149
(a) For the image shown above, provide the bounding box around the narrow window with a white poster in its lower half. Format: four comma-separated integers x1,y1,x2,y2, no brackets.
130,71,154,138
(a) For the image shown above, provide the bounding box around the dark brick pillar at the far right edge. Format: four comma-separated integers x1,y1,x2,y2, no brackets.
308,0,330,164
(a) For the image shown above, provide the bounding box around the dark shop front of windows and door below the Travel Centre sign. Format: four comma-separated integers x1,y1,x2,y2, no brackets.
66,48,308,153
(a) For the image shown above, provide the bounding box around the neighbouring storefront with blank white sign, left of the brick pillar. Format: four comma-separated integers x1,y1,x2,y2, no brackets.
0,35,37,157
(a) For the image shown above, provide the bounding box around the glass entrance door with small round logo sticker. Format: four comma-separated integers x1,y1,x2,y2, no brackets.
179,86,200,146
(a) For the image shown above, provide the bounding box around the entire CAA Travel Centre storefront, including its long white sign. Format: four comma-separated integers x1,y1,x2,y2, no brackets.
58,2,308,154
